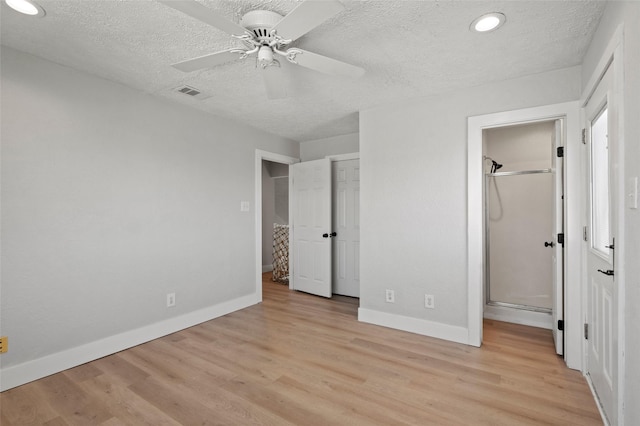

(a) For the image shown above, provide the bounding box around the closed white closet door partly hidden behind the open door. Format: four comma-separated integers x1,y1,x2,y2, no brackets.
331,159,360,297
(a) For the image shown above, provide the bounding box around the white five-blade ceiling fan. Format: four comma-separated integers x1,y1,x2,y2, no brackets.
159,0,364,99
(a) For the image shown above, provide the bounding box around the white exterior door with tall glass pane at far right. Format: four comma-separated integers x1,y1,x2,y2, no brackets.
584,66,618,424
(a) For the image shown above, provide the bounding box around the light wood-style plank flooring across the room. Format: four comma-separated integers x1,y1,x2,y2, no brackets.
0,279,602,426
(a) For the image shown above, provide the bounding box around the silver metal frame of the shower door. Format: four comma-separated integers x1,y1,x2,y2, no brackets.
484,169,553,314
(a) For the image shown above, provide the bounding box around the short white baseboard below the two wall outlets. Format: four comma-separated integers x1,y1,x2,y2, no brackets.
358,308,469,345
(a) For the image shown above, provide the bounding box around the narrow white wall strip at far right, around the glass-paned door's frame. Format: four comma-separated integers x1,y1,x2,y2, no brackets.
582,1,640,425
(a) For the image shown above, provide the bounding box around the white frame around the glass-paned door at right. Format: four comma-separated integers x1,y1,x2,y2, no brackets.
580,24,626,424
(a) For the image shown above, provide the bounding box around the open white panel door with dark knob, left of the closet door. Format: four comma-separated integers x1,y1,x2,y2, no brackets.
289,159,332,297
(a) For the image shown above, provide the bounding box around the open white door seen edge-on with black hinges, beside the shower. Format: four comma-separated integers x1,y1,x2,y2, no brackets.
551,120,564,355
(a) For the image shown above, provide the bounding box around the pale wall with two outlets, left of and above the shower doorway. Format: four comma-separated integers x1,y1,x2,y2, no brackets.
360,67,580,341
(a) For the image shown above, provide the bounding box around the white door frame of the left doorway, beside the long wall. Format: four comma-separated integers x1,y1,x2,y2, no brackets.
254,149,300,302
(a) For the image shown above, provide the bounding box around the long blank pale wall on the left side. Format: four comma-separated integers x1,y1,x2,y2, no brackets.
0,47,299,388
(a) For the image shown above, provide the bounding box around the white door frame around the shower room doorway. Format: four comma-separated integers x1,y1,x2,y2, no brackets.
467,102,583,370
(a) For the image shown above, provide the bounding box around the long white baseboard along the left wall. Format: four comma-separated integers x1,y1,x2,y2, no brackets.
0,293,260,391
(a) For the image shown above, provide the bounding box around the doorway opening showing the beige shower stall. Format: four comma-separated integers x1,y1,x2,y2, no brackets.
483,120,563,336
